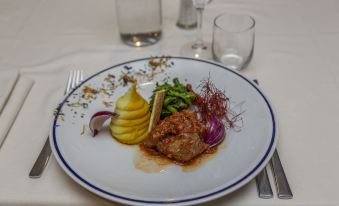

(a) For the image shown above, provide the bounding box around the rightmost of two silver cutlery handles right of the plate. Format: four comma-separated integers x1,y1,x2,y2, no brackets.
271,150,293,199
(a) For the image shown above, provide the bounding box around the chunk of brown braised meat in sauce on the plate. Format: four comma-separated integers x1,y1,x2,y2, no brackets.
142,110,208,162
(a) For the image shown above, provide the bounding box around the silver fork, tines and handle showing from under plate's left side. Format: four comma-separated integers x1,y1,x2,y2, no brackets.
29,70,84,178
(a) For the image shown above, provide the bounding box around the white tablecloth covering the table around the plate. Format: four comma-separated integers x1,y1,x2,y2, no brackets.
0,0,339,206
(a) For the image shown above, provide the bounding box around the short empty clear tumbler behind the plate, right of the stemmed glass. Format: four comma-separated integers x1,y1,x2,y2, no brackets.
212,14,255,70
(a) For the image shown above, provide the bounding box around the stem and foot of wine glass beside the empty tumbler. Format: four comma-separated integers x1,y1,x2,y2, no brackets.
181,0,212,59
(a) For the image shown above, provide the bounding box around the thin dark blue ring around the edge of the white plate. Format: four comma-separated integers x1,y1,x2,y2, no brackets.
52,56,276,205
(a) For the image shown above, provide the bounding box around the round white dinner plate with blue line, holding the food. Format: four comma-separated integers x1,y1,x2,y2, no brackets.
50,57,277,205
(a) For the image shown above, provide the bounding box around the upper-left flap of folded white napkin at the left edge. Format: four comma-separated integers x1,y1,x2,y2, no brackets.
0,70,19,114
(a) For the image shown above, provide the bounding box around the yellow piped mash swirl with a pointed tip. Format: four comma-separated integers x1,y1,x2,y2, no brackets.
110,83,150,144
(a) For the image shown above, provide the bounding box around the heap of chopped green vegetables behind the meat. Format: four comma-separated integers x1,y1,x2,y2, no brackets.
150,78,196,119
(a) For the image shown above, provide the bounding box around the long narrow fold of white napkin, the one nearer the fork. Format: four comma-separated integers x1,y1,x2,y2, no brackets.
0,77,34,147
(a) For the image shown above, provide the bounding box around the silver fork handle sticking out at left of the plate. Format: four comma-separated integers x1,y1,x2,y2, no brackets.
29,137,52,178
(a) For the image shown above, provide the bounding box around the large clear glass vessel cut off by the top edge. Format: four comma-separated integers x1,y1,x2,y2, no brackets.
116,0,162,47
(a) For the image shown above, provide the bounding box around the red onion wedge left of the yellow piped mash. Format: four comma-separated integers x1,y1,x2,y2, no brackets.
89,111,118,137
